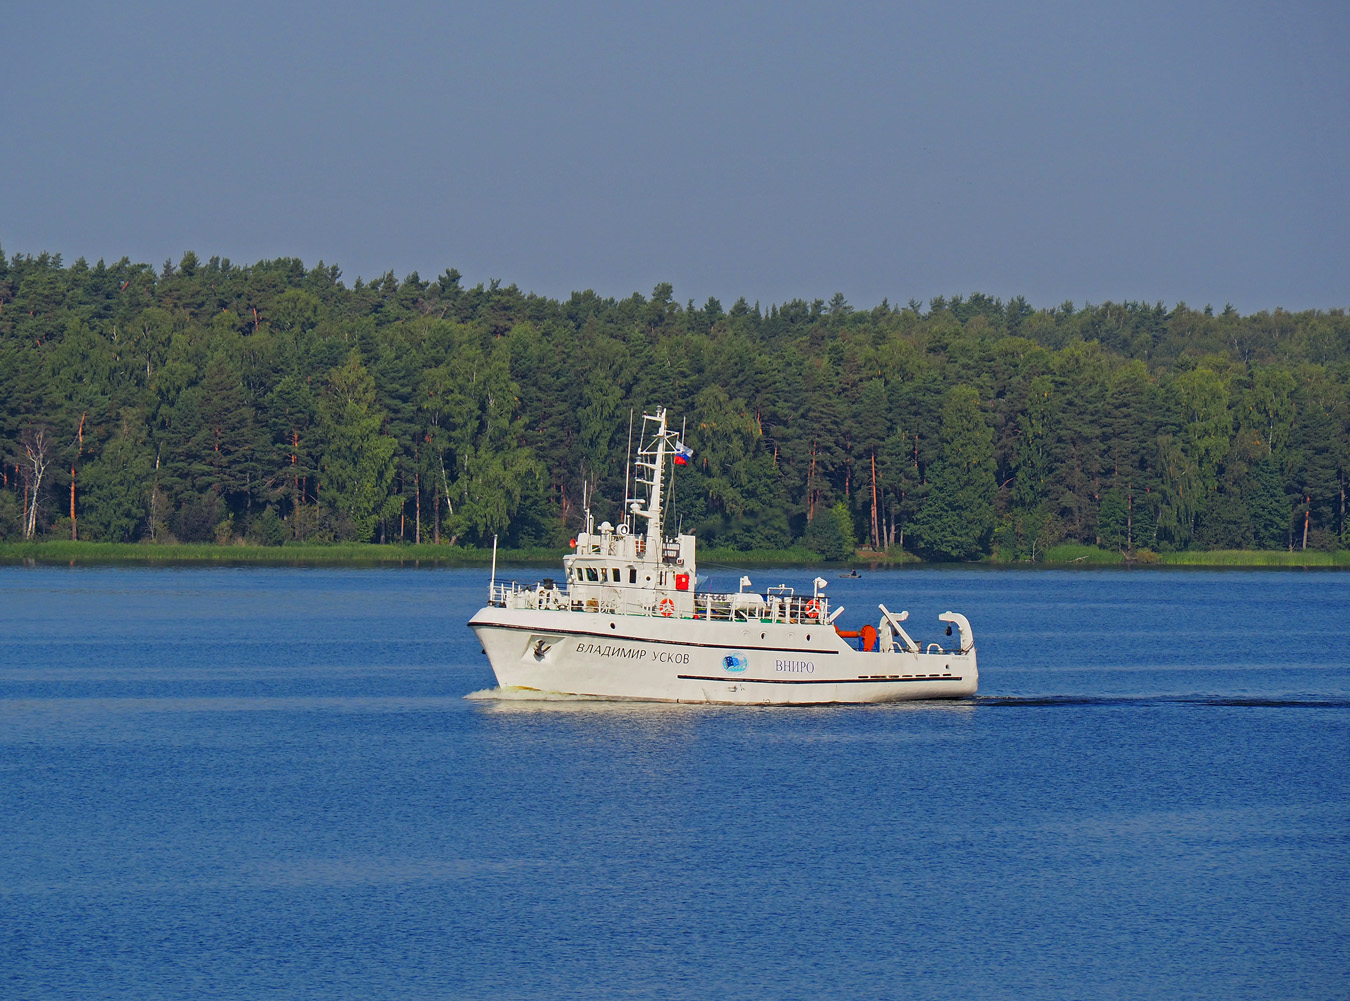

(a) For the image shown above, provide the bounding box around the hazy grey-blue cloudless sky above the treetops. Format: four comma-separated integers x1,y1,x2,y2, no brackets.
0,0,1350,312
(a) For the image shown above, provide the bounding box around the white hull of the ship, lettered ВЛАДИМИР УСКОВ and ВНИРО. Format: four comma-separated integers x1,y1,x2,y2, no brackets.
468,605,979,705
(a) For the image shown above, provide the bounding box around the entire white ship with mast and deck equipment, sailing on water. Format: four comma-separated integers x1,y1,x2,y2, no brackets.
468,408,979,705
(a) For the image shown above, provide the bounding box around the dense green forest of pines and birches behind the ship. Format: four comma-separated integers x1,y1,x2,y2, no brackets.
0,250,1350,561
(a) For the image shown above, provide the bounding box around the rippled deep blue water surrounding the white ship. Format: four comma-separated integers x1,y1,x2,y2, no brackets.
0,566,1350,998
